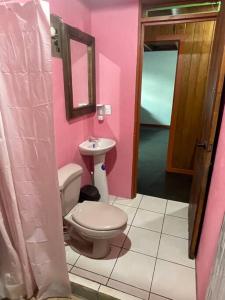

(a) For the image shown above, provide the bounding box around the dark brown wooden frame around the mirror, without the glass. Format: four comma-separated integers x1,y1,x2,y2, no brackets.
62,23,96,121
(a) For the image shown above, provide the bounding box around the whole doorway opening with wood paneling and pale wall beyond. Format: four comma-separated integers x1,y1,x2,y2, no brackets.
137,20,215,203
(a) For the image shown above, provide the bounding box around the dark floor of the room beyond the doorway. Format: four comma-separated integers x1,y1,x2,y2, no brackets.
138,126,192,203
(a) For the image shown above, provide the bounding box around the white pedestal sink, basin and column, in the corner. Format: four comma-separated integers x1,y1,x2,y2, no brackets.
79,138,116,202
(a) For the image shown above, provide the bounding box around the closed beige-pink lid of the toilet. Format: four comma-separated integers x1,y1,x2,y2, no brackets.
72,201,128,231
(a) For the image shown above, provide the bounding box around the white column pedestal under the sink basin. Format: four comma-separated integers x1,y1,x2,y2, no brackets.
94,154,109,202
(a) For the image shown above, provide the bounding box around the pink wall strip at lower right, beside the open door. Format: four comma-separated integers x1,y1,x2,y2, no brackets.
196,98,225,300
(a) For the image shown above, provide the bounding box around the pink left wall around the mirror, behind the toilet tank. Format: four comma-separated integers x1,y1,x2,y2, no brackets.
49,0,93,184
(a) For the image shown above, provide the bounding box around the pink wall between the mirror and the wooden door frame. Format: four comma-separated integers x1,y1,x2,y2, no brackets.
91,0,138,197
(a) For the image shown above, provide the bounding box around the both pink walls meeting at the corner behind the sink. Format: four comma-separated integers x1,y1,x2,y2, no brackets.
49,0,138,197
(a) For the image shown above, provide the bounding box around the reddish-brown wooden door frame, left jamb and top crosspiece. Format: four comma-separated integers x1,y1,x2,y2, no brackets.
131,5,218,198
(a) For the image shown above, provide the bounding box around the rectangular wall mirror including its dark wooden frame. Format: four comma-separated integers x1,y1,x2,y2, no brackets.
62,24,96,120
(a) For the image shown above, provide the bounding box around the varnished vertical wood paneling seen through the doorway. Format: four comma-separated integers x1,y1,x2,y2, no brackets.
144,20,215,175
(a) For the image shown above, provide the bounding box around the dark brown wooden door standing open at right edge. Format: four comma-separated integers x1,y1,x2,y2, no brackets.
189,0,225,258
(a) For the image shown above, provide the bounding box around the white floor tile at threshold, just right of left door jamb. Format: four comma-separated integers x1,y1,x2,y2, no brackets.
139,196,167,214
